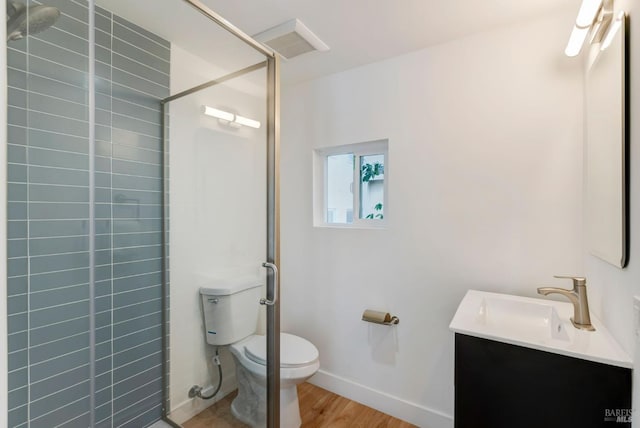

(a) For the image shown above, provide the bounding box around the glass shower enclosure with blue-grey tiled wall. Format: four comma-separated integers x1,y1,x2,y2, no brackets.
0,0,280,428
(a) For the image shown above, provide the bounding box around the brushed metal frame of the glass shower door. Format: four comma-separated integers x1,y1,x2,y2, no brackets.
160,0,280,428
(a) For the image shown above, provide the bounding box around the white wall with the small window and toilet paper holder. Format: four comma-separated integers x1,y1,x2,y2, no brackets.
281,10,583,428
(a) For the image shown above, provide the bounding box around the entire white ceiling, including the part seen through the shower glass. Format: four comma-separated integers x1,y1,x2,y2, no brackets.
98,0,580,83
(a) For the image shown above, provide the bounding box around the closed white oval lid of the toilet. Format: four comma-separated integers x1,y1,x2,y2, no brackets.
244,333,318,367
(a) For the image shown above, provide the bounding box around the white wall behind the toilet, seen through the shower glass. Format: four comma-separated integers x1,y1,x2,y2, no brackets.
169,44,266,423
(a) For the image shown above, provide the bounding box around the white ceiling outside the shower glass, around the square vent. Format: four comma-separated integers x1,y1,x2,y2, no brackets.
199,0,580,82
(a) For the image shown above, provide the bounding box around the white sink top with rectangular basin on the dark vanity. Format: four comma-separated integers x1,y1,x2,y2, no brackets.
449,290,633,368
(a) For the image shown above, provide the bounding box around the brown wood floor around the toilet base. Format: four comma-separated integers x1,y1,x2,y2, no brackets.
183,383,414,428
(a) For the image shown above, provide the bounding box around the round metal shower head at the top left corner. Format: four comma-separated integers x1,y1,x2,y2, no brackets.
7,1,60,41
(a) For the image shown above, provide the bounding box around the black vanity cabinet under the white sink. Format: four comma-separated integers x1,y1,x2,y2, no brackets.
454,333,631,428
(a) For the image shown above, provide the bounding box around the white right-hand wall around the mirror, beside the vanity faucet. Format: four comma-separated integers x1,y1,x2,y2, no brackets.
585,0,640,426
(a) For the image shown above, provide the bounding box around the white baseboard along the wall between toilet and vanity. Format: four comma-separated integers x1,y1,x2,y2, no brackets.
308,370,453,428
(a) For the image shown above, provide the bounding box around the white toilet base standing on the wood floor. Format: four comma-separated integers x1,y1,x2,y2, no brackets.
231,361,302,428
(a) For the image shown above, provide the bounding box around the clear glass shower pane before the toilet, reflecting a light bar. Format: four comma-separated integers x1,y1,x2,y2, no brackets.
166,59,276,423
